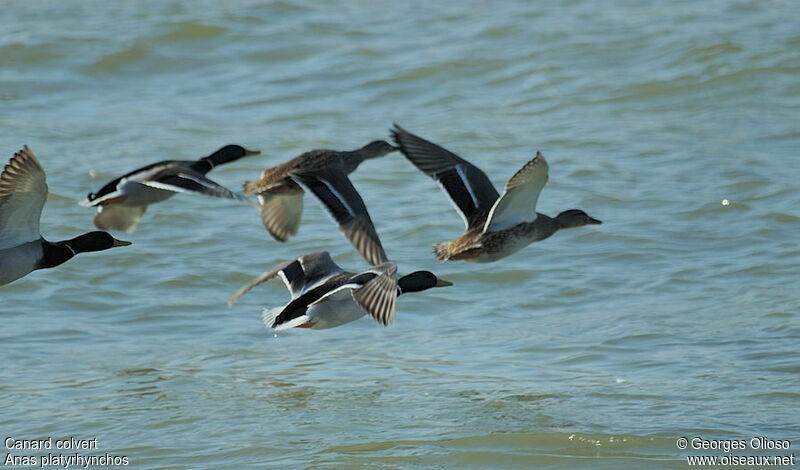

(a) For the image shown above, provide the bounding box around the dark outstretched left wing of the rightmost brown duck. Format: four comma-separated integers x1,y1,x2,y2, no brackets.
392,124,498,228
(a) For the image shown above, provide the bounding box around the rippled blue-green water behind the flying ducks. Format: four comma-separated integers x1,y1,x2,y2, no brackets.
0,0,800,469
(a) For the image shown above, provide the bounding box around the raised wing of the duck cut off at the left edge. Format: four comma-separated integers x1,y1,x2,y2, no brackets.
0,145,47,250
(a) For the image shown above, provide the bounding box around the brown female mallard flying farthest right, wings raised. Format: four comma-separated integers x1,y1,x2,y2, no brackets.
392,124,602,263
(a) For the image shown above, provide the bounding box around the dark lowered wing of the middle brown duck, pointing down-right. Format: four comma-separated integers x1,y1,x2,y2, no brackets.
291,167,387,266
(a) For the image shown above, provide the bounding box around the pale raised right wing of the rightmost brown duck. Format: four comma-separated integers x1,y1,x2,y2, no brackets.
483,152,547,232
